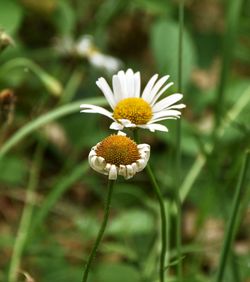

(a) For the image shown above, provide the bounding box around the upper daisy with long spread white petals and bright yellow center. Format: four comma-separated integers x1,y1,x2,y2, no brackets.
80,69,185,131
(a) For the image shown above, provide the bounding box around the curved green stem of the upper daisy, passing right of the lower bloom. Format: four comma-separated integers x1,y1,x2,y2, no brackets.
146,164,167,282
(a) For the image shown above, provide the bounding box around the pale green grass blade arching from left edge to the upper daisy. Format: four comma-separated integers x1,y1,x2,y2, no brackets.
0,98,106,160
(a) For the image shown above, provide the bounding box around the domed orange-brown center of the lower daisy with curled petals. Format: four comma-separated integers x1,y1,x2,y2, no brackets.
96,135,140,166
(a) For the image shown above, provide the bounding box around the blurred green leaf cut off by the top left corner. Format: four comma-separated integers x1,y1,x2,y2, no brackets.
0,0,23,34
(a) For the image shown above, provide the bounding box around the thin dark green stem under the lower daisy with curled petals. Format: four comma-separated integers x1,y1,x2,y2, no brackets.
82,180,115,282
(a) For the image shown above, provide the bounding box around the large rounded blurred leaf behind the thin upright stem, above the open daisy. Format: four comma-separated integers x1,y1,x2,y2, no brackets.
150,20,196,86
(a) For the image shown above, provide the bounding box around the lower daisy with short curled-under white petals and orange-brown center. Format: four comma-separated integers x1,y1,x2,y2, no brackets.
89,131,150,180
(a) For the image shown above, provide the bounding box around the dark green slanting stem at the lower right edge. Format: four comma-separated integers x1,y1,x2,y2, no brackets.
215,151,250,282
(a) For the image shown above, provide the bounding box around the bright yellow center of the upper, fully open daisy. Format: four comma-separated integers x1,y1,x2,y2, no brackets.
113,98,152,124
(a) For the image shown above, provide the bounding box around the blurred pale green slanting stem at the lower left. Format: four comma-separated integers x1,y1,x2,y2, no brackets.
8,145,43,282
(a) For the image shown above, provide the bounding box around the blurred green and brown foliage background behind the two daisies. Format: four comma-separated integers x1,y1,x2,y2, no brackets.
0,0,250,282
